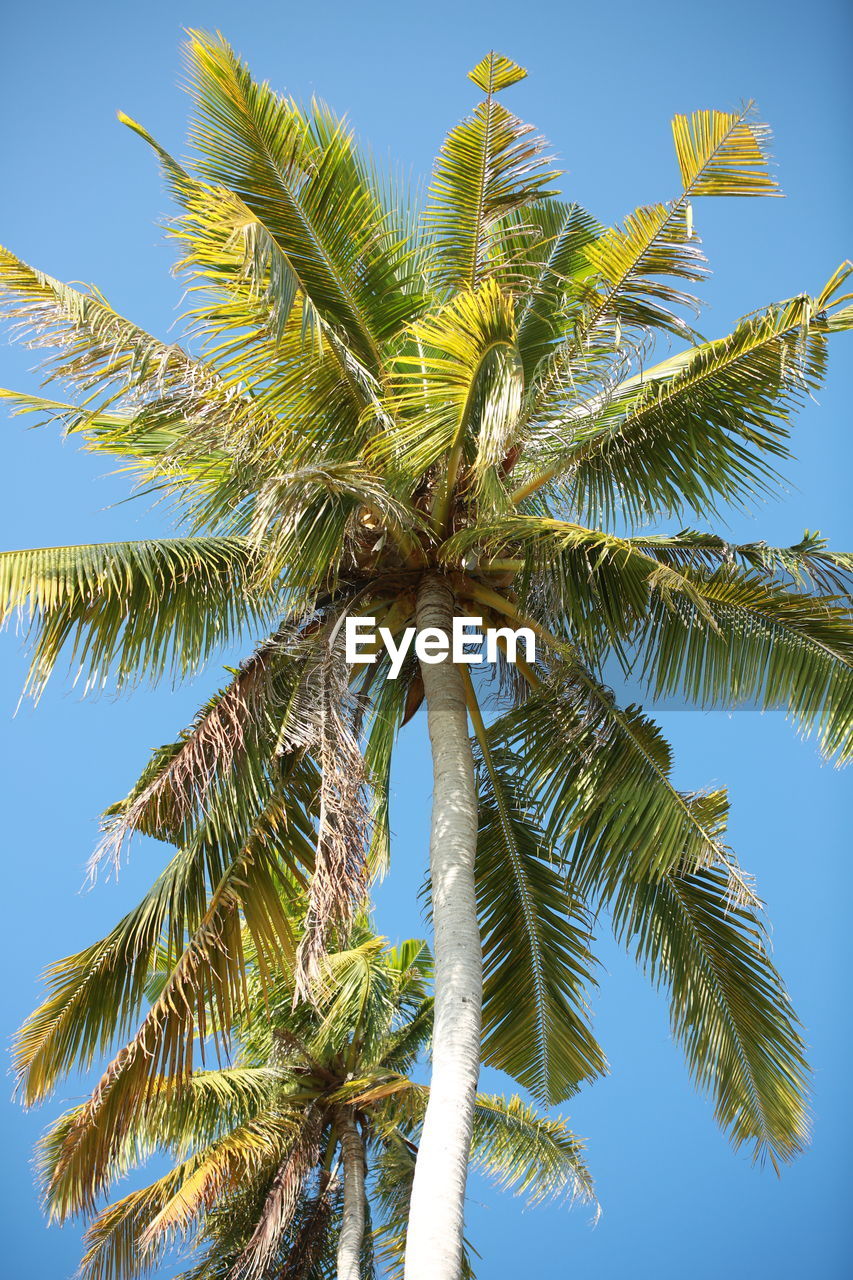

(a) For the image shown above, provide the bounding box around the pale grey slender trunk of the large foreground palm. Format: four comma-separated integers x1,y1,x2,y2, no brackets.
406,577,483,1280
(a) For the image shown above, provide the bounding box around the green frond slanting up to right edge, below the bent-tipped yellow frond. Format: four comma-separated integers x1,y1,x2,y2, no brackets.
516,282,845,524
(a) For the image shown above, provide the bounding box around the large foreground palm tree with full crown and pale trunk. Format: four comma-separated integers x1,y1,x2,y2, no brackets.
0,27,853,1280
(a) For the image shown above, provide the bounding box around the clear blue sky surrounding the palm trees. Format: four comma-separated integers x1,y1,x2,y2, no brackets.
0,0,853,1280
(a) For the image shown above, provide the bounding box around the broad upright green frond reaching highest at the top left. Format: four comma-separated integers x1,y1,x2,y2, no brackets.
181,33,418,372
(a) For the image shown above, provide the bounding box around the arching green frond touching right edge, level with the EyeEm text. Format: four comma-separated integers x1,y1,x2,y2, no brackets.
446,516,853,759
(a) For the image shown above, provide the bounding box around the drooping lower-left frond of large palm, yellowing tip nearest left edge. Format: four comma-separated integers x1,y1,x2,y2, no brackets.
15,742,316,1105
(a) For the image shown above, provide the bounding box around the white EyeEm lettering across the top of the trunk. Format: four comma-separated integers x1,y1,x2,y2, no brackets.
345,618,537,680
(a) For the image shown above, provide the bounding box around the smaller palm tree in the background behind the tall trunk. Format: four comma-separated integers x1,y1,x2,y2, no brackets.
41,923,593,1280
